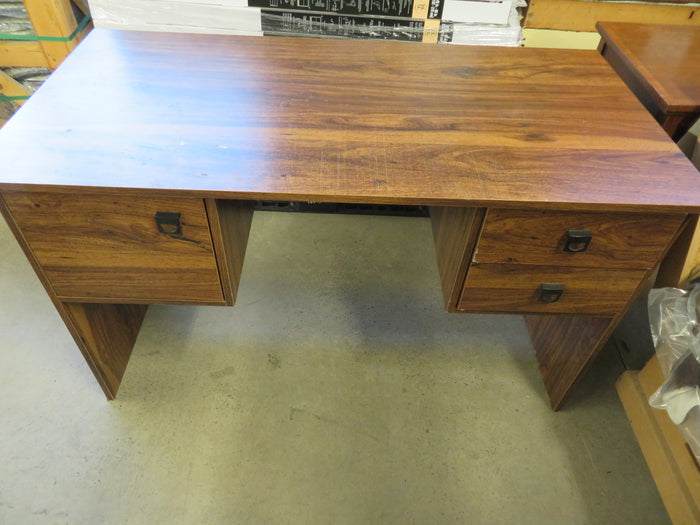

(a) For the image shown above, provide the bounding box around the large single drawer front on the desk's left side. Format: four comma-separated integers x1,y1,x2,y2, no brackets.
3,192,224,304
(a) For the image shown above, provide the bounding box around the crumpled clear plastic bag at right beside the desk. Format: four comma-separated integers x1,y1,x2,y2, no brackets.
649,286,700,459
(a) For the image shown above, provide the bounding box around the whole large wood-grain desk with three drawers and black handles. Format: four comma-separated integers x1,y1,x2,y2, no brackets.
0,30,700,408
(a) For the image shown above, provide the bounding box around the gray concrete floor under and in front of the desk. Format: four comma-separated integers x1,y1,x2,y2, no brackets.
0,213,668,525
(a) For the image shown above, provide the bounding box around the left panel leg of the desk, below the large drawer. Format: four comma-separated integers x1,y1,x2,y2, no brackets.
57,303,148,399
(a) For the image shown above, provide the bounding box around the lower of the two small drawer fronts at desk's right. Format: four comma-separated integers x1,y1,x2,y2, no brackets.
458,264,646,315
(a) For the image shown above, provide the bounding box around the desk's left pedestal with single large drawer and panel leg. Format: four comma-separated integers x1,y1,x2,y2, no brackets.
0,191,253,399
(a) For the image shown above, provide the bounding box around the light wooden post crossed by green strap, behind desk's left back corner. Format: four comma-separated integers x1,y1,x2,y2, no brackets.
24,0,78,69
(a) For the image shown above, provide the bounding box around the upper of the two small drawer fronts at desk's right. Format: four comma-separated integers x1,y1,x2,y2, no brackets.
473,209,685,269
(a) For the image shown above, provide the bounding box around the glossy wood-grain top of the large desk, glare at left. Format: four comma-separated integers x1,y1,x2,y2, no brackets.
0,29,700,211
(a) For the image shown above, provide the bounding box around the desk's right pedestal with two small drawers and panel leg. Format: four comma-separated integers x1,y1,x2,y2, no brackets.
431,208,686,410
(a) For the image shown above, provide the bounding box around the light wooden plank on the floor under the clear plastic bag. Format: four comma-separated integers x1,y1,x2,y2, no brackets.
616,356,700,525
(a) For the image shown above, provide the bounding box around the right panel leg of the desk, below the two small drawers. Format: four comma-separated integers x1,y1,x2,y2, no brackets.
525,315,614,410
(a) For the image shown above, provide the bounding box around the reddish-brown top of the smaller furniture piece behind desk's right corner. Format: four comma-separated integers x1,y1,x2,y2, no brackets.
596,22,700,112
